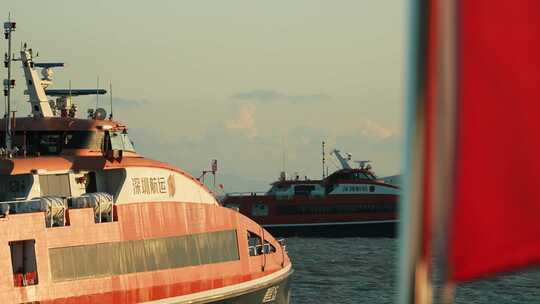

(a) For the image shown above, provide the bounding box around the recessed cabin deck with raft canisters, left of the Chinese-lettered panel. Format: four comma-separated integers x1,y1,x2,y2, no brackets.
0,169,120,227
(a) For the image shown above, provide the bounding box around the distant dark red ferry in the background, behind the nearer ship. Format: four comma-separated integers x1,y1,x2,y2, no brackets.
222,142,400,237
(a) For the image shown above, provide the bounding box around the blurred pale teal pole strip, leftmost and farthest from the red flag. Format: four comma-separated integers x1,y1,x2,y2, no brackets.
397,0,428,304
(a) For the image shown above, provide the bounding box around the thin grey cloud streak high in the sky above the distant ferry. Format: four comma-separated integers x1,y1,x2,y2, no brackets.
232,89,330,103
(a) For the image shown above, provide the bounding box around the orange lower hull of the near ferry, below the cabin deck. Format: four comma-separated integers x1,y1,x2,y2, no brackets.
0,202,292,303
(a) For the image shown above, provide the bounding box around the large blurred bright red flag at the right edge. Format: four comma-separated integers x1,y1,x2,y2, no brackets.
449,0,540,281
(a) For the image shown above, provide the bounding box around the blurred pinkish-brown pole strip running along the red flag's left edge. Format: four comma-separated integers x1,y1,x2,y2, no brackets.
433,0,458,304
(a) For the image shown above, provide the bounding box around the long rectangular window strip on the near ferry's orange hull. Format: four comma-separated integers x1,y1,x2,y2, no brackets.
49,230,240,281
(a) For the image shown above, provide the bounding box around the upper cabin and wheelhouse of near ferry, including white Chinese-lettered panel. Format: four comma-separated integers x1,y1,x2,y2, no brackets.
0,118,216,227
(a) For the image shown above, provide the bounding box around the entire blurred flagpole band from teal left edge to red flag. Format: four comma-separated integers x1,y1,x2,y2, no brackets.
398,0,457,304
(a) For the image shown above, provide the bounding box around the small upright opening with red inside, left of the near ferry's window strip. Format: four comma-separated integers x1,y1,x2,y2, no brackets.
9,240,38,287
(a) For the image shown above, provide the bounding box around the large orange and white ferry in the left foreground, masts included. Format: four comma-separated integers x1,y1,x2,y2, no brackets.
0,21,293,304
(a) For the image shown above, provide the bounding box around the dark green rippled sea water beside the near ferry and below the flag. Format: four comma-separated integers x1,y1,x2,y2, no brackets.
287,237,540,304
